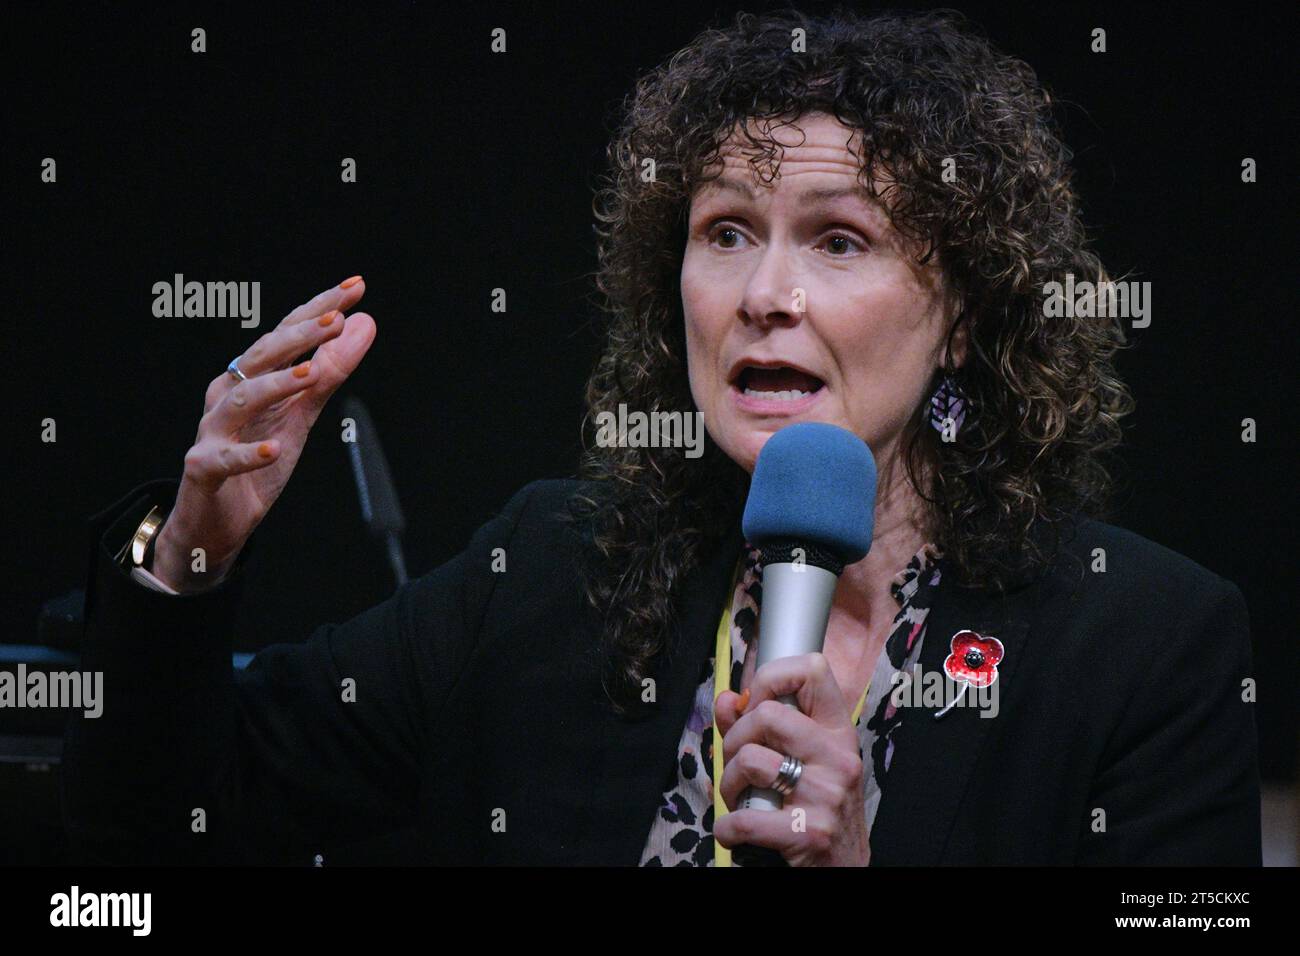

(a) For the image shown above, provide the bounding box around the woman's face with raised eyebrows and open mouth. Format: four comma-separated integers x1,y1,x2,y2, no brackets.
681,113,965,471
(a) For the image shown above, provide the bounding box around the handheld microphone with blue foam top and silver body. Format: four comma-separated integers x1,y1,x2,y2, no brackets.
740,421,876,810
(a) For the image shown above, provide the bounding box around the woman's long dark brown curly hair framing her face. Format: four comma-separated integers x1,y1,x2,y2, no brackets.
571,9,1132,710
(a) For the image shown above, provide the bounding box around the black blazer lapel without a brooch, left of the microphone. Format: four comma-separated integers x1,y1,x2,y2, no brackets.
579,529,742,866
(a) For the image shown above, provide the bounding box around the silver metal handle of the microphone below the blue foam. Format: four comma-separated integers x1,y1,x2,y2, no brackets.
740,563,840,810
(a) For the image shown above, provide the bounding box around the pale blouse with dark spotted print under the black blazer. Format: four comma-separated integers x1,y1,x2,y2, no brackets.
641,544,940,866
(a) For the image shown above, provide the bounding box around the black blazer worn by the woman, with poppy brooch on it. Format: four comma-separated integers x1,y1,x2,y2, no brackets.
64,481,1260,865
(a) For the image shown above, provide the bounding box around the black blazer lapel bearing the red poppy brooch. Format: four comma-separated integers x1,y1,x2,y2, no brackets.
871,562,1035,866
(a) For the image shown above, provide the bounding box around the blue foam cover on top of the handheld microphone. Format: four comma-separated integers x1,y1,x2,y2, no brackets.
742,421,876,564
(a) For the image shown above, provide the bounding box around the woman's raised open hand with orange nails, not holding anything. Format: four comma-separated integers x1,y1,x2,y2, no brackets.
151,276,376,592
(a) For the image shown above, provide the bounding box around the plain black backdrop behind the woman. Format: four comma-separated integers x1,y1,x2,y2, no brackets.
0,3,1300,796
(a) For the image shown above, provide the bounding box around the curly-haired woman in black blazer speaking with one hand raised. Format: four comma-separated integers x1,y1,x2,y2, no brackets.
65,7,1260,865
